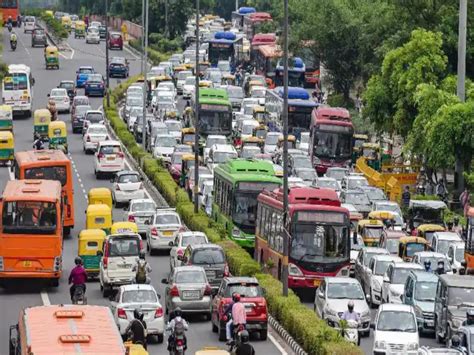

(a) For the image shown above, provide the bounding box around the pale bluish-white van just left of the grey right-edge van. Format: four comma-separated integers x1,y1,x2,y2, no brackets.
402,270,438,332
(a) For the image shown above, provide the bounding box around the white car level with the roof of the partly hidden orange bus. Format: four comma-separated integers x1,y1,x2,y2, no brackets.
94,140,125,178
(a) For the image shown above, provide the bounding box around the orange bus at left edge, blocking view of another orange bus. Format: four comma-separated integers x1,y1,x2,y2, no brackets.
0,180,63,287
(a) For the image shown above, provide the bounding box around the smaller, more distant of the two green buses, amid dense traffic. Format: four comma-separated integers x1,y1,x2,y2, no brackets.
199,88,232,138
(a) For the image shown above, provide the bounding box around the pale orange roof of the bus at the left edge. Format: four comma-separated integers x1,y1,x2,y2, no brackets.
3,180,61,202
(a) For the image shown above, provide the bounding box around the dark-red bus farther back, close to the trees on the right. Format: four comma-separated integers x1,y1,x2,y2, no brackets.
310,106,354,174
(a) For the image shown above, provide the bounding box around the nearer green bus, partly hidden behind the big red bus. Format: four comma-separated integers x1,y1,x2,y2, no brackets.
212,159,282,248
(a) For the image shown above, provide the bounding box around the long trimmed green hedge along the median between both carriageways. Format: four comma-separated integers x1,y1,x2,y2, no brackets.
104,77,363,355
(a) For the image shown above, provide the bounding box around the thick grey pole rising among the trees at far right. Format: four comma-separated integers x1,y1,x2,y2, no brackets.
454,0,467,194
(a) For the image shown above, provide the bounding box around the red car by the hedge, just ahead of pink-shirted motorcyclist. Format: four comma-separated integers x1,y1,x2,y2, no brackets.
211,277,268,340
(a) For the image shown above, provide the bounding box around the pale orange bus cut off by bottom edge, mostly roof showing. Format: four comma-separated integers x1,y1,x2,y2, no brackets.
10,305,126,355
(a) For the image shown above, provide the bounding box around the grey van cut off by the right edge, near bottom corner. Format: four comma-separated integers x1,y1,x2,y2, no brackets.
435,275,474,342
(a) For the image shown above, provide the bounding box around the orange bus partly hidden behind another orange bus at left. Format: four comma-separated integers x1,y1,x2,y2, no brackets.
13,149,74,235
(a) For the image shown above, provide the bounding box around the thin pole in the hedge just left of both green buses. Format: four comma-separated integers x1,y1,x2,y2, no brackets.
194,0,201,213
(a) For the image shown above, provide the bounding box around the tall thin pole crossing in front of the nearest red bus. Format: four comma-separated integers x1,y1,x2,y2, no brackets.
282,0,290,297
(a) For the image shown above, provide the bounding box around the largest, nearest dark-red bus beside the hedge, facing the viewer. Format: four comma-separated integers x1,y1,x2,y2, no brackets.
255,186,350,289
